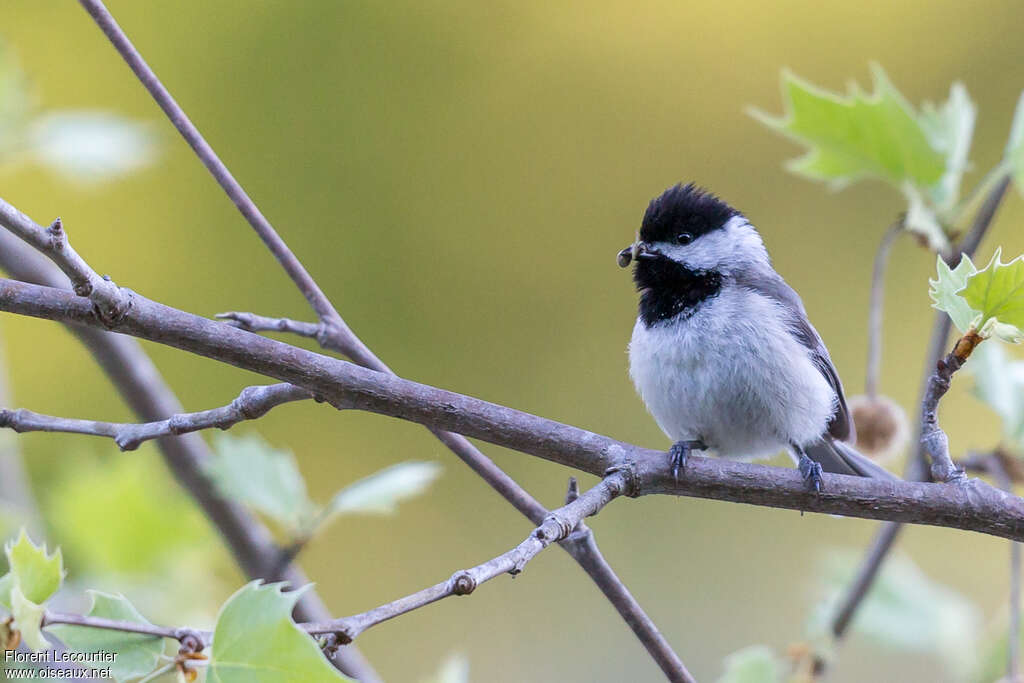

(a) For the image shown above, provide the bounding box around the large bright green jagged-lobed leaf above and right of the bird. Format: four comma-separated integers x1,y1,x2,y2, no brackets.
752,66,946,187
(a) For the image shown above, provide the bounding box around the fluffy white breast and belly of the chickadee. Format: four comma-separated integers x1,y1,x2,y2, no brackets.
630,284,838,458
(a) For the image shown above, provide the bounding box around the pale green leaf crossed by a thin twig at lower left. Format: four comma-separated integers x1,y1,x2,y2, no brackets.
46,591,164,683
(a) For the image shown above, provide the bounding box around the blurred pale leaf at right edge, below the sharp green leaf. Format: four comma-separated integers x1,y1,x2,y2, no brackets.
967,344,1024,449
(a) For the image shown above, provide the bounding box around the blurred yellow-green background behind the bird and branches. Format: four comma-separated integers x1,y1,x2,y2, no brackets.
6,0,1024,682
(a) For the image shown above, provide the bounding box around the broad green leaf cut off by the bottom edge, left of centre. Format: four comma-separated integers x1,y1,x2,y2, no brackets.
207,582,349,683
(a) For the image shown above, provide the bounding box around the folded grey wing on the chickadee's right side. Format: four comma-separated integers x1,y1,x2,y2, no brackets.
736,266,856,442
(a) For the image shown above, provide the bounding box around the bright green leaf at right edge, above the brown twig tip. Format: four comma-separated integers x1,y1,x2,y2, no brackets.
961,249,1024,342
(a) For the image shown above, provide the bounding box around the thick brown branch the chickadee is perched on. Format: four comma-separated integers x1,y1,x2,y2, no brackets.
9,280,1024,540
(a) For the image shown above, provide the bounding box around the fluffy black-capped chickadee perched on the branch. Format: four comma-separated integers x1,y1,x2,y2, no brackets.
618,183,894,492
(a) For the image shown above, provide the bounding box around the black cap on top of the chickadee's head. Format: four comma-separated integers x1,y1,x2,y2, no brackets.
640,182,739,243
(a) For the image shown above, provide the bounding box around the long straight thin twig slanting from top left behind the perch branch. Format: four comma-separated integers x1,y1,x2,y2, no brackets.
79,5,681,679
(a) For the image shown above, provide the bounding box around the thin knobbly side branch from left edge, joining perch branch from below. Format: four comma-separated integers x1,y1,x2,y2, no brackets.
0,384,313,450
